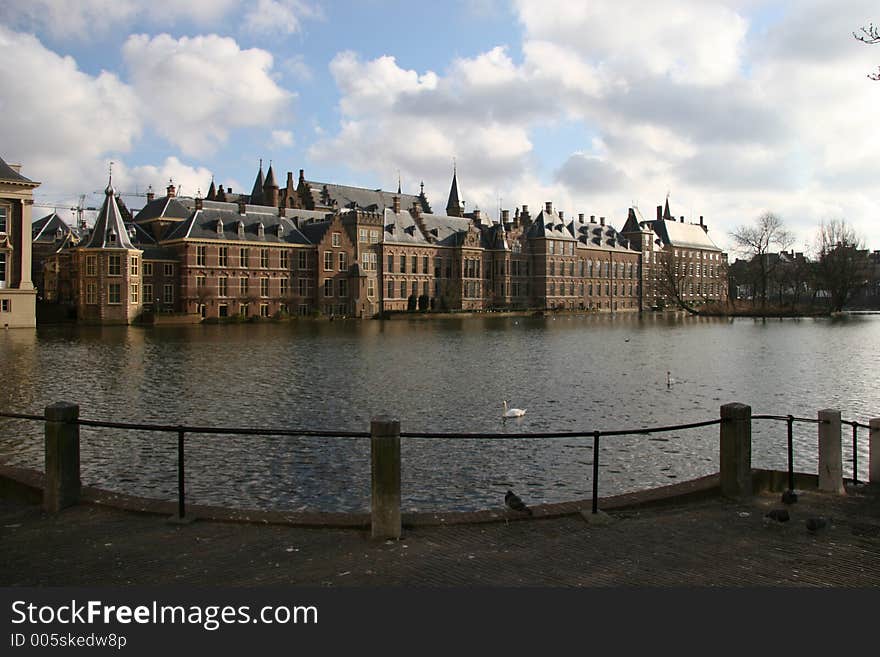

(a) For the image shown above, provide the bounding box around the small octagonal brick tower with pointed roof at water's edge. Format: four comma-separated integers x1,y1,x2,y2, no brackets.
76,180,143,324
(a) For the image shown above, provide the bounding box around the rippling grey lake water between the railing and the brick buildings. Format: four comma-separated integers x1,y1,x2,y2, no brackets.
0,314,880,511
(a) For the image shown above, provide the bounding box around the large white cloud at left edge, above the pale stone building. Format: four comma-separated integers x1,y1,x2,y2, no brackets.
0,26,142,198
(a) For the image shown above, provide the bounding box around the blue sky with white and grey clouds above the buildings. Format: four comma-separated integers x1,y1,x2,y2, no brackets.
0,0,880,252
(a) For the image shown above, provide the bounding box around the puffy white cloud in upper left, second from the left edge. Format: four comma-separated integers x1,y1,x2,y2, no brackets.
123,34,292,155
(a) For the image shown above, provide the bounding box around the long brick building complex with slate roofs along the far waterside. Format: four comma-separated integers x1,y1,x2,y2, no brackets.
45,163,726,323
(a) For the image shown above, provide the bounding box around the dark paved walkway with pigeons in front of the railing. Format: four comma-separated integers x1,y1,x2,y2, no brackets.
0,487,880,587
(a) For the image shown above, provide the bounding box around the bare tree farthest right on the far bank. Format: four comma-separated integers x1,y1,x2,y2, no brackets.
816,219,868,312
